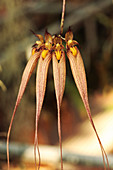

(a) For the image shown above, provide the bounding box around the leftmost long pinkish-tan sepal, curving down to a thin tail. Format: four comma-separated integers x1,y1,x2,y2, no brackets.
7,52,40,170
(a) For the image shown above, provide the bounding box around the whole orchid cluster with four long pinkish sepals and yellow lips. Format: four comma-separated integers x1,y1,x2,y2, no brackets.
7,1,109,170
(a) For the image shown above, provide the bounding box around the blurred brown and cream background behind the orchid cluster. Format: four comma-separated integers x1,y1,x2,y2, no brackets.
0,0,113,170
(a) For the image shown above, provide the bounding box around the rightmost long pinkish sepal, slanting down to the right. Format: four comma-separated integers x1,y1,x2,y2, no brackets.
67,50,109,169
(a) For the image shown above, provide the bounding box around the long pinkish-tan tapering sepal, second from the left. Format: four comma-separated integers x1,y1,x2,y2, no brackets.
34,52,51,169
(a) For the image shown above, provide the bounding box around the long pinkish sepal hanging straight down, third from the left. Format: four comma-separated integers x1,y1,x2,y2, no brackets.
52,51,66,170
